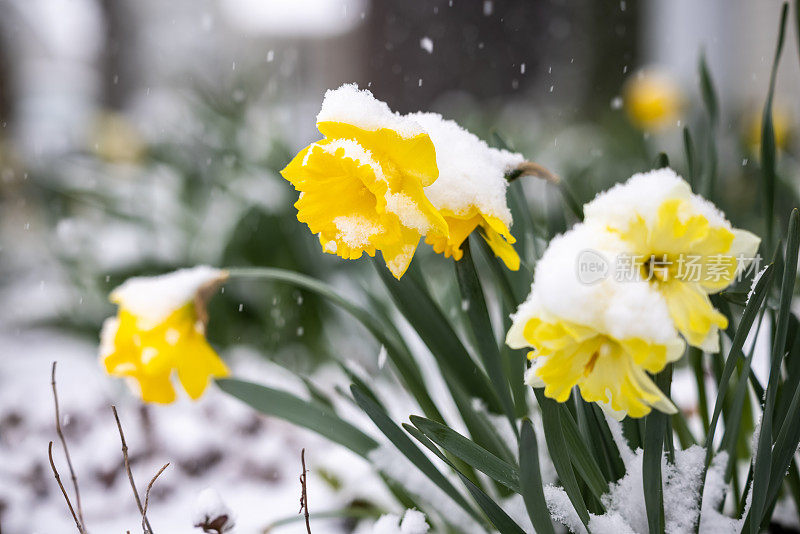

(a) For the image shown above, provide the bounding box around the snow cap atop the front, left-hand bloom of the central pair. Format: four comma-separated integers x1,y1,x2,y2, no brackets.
317,83,425,138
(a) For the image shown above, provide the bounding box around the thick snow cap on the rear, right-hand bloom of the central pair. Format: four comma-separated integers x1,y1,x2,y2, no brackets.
407,113,525,226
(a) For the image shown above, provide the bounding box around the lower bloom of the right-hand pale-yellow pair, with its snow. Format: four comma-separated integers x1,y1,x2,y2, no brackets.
506,225,684,418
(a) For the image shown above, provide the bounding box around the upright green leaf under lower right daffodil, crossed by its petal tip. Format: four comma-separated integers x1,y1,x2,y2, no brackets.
642,364,672,534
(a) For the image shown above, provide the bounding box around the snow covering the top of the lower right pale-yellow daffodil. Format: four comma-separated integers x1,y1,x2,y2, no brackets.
507,224,677,348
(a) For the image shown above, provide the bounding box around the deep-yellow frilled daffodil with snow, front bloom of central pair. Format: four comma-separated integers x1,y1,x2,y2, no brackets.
281,85,449,278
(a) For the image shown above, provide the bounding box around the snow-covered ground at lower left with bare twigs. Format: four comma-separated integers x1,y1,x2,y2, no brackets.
0,331,375,534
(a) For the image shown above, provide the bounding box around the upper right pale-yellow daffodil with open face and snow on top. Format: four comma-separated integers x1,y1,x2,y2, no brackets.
584,169,760,352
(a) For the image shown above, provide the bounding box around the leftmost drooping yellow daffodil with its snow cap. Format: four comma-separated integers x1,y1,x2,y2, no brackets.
100,266,229,403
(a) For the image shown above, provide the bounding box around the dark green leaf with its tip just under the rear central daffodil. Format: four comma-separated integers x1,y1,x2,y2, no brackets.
453,239,517,434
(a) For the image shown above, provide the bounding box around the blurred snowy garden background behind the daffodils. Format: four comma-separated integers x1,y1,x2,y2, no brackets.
0,0,800,534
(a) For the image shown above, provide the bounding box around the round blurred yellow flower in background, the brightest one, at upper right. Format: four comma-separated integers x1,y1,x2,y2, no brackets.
623,69,684,131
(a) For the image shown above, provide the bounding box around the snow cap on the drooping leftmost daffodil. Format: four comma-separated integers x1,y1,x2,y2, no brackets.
111,265,227,325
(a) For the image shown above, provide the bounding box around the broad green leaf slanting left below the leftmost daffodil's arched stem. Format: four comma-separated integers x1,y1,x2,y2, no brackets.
216,378,378,458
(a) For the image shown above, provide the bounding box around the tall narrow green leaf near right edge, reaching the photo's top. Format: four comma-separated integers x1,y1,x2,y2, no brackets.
761,2,789,250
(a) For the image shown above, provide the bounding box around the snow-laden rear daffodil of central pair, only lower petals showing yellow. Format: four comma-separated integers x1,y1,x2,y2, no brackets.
409,113,524,271
